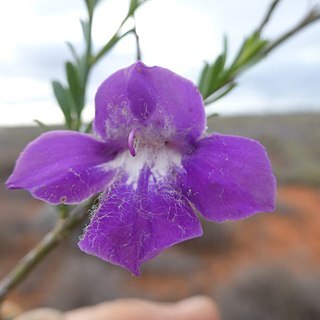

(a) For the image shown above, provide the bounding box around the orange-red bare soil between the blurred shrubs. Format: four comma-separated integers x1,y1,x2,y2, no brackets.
0,186,320,314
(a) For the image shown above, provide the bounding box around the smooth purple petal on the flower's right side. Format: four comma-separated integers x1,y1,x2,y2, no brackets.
182,134,276,221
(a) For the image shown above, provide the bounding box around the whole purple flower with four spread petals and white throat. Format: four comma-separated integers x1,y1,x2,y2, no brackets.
7,62,275,274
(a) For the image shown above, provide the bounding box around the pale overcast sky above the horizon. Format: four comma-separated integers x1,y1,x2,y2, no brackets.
0,0,320,125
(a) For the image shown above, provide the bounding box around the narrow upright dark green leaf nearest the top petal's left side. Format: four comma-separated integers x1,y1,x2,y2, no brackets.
66,62,84,117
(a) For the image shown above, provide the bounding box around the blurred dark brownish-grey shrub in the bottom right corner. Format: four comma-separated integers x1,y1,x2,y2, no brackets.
218,266,320,320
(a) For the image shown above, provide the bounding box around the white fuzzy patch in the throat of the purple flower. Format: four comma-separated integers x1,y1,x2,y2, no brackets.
103,145,181,188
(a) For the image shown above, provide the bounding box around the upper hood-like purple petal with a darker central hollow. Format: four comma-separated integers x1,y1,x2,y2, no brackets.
94,62,206,146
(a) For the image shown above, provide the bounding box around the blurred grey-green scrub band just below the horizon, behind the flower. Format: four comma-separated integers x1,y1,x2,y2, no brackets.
0,113,320,185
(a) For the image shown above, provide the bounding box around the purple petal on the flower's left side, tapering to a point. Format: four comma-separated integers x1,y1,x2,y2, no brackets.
6,131,116,204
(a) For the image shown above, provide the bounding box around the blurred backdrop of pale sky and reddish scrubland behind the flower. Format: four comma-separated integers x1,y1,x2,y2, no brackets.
0,0,320,320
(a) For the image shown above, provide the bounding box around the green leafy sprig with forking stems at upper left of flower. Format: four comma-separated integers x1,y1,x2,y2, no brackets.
52,0,147,131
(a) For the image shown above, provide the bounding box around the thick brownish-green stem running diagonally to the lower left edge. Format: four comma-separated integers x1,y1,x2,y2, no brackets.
0,201,92,306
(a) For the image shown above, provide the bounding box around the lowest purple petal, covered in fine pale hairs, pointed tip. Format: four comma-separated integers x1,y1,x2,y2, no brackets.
79,166,202,275
